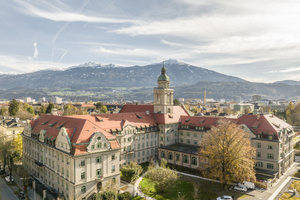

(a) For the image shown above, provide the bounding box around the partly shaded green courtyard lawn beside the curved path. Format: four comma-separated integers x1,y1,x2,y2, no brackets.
140,178,249,200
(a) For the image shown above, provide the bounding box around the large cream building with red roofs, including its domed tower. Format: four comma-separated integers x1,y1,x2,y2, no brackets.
22,67,294,199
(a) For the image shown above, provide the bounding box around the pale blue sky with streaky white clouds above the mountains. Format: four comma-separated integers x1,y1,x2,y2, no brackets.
0,0,300,82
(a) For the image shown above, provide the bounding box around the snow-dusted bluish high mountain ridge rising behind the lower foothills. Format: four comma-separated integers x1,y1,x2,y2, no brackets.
0,59,245,89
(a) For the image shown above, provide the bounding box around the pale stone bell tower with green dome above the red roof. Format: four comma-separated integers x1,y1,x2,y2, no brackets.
153,65,174,114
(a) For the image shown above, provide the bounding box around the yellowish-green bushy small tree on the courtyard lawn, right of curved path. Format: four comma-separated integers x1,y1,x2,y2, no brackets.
146,158,179,192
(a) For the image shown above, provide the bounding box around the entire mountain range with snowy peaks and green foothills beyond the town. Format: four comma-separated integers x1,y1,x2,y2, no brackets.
0,59,300,101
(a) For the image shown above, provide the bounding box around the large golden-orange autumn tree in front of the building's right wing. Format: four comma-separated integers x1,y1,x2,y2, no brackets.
199,120,256,189
